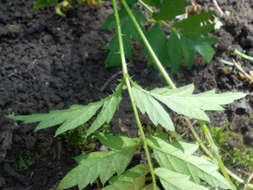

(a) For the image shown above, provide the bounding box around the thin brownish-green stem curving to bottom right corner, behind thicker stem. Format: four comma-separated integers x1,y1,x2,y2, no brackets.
182,116,253,188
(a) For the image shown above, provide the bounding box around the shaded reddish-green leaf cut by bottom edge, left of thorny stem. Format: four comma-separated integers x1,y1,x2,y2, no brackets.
103,164,149,190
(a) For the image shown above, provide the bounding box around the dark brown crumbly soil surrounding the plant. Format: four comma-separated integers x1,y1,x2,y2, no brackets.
0,0,253,190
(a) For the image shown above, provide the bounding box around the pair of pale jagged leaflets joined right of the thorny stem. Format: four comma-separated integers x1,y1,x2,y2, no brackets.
133,84,245,131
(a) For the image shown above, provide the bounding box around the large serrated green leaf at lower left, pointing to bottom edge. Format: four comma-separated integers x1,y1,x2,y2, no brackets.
58,145,137,189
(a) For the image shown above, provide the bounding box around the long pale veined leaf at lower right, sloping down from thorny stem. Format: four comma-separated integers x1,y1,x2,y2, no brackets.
148,137,230,189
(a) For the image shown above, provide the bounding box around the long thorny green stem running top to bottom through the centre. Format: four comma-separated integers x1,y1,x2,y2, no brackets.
112,0,156,190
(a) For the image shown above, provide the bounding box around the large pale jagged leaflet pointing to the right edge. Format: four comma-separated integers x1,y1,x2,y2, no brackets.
150,84,247,121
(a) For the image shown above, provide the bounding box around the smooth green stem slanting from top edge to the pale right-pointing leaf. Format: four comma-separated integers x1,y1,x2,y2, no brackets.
120,0,176,88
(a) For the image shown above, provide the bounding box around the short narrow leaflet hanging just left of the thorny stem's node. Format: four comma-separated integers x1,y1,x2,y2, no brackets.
87,93,122,136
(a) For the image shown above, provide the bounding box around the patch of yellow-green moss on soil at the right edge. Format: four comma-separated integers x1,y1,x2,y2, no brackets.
210,126,253,172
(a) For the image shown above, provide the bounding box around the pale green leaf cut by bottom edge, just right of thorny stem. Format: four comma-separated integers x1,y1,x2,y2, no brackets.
155,168,208,190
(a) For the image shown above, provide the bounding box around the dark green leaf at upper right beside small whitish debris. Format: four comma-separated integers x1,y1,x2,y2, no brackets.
172,12,214,34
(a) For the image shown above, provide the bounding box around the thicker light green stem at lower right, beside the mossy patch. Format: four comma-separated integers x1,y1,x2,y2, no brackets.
199,121,236,190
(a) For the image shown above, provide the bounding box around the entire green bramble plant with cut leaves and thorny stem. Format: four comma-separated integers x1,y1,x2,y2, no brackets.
9,0,252,190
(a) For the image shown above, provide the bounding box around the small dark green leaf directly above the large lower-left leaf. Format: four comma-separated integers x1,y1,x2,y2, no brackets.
97,133,140,150
